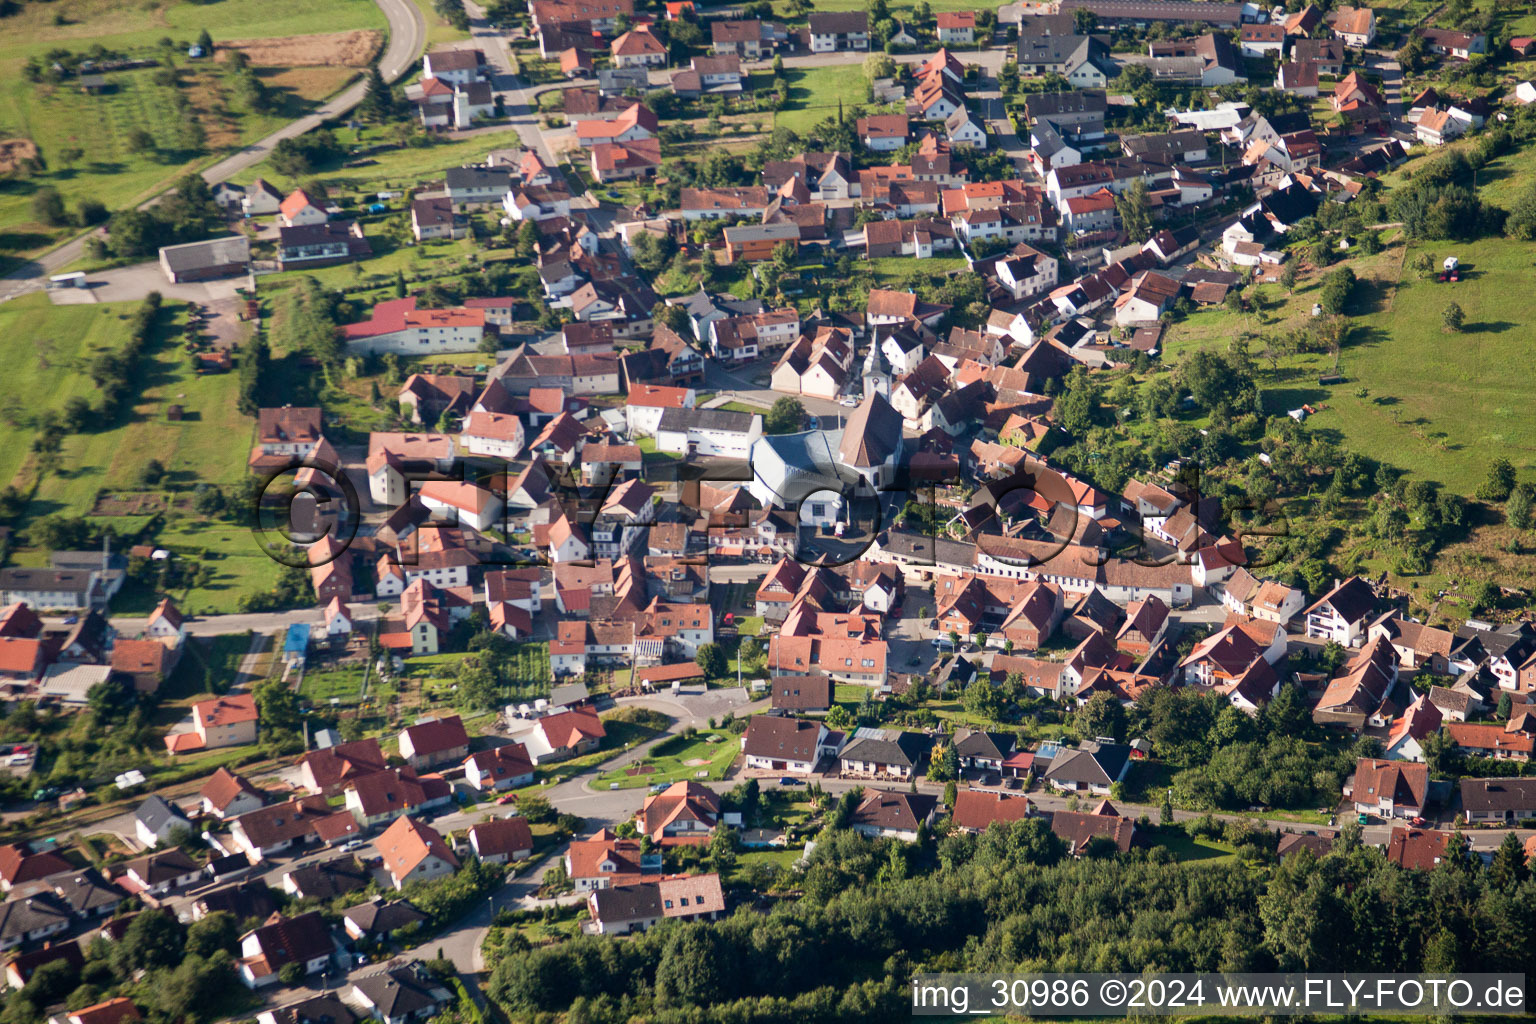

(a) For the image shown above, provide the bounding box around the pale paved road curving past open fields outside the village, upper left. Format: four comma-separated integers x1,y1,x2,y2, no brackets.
0,0,427,302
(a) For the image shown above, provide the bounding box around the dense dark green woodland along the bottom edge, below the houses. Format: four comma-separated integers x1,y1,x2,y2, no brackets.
488,798,1536,1024
